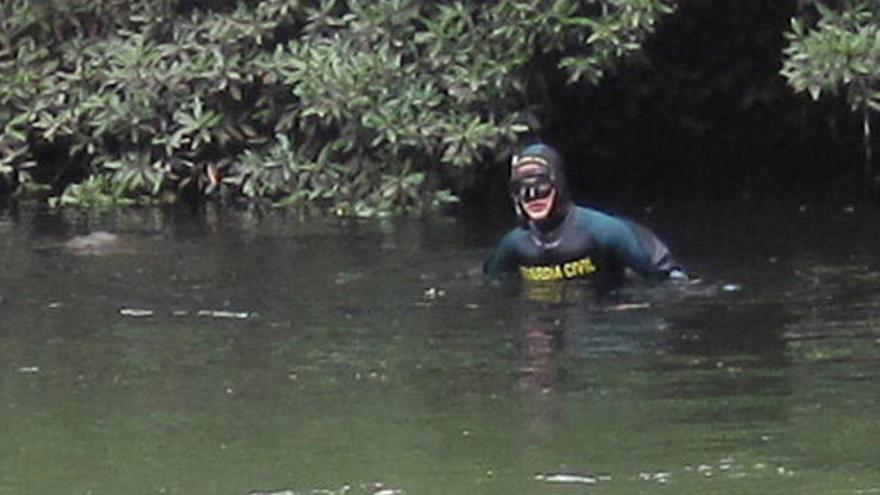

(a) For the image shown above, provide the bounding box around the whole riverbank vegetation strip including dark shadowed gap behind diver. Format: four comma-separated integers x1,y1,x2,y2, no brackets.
0,0,880,215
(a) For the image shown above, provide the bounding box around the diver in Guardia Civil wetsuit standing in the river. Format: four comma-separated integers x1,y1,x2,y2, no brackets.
483,144,688,288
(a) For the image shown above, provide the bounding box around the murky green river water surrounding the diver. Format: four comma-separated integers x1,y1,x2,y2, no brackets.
0,205,880,495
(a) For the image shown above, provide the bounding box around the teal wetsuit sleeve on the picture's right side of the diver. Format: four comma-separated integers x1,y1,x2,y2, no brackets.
604,218,684,279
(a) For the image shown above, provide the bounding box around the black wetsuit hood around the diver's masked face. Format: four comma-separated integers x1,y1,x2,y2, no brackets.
510,144,573,244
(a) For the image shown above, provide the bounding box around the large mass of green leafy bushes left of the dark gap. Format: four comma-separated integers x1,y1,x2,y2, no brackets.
0,0,673,215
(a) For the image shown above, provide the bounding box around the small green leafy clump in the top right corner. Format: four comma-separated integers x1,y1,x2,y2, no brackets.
781,0,880,112
